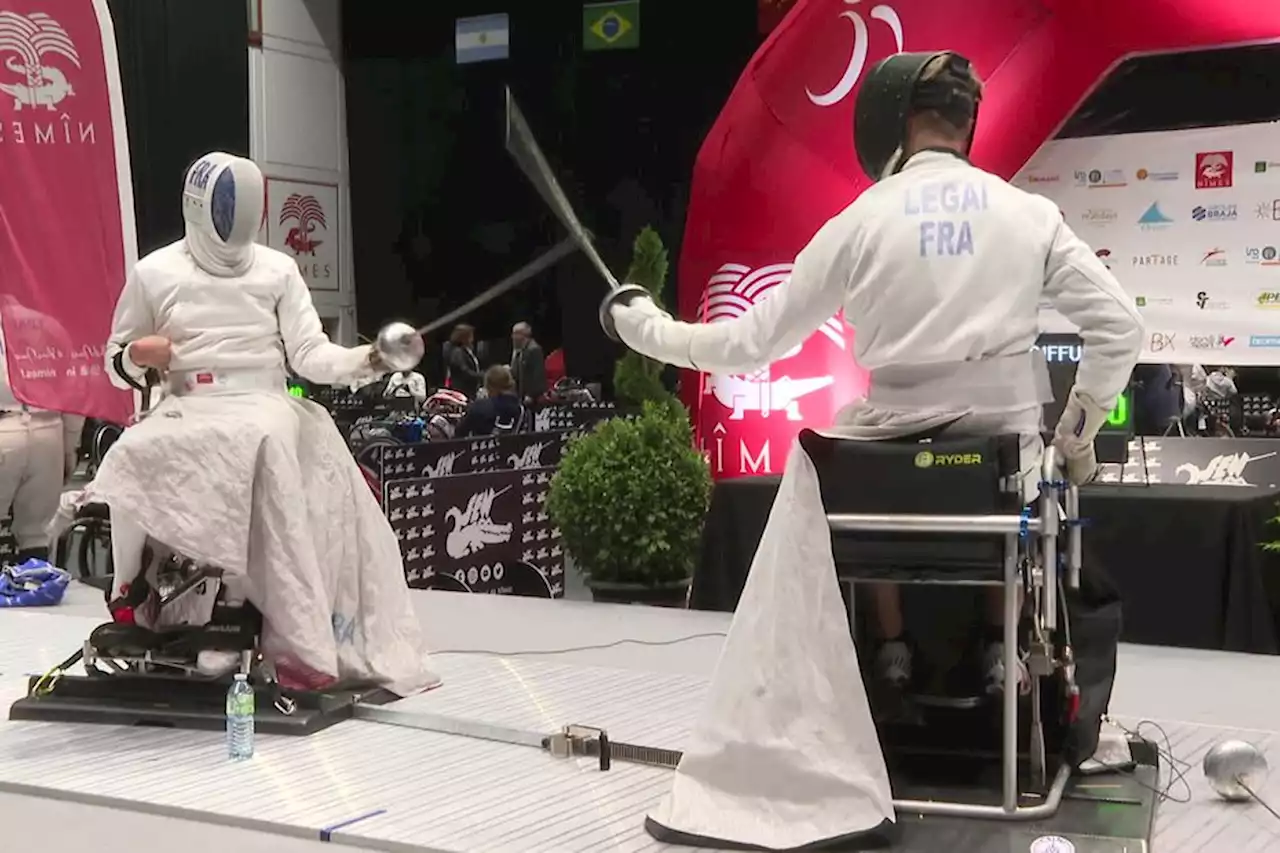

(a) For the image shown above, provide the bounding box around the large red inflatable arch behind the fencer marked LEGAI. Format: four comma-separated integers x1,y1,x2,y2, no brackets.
678,0,1280,478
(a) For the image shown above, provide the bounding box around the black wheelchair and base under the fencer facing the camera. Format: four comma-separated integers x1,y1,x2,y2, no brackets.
17,391,396,736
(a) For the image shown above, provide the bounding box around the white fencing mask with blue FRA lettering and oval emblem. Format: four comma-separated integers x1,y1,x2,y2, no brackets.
182,151,266,277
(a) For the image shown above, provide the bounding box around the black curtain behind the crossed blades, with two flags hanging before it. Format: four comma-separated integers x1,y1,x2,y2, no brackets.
343,0,760,380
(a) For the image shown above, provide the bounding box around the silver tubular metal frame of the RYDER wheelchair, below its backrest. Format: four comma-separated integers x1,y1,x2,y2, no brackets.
827,446,1080,821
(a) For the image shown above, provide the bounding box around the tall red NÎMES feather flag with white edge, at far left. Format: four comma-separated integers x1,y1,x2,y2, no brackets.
0,0,137,423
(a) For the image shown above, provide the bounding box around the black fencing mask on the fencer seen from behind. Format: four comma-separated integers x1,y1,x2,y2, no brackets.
854,51,980,181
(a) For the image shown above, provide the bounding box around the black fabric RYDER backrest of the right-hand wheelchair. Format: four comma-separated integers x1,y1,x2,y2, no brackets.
800,430,1023,583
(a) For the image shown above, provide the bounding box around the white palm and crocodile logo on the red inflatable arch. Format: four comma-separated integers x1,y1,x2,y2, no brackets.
701,264,847,421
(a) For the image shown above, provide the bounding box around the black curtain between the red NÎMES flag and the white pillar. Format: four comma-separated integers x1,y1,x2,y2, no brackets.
108,0,248,255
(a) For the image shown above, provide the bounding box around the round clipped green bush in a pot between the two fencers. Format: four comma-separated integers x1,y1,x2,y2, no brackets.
547,401,712,587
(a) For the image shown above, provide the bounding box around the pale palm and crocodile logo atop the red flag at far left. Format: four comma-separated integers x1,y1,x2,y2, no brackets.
0,12,81,111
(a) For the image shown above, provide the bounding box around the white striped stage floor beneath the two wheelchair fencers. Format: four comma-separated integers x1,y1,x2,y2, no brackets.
0,588,1280,853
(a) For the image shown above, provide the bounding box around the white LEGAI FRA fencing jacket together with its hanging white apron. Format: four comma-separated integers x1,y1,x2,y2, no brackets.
613,152,1142,849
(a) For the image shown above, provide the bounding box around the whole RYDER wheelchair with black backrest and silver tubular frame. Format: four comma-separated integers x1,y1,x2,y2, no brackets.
800,430,1085,821
